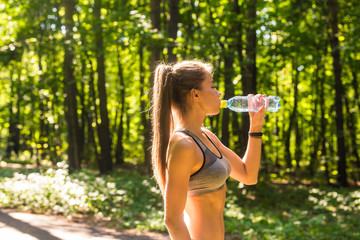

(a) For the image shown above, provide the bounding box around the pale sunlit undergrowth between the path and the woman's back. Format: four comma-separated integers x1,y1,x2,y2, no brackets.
0,165,165,231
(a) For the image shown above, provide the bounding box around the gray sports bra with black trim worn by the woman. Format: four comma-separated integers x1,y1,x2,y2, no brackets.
176,129,231,196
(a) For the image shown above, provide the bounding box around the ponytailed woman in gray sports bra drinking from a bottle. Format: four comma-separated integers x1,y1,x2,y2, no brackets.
152,61,265,240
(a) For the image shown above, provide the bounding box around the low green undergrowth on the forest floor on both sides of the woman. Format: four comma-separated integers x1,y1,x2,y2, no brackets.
0,162,360,240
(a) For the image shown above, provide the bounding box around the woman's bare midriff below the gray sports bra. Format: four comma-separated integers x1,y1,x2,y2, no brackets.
185,186,226,240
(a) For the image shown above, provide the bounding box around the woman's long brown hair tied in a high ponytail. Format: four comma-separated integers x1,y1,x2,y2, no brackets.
151,61,212,192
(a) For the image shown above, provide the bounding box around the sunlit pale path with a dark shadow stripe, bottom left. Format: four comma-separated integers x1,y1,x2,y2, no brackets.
0,209,170,240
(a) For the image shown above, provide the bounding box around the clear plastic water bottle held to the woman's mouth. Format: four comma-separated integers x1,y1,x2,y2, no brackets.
220,96,281,112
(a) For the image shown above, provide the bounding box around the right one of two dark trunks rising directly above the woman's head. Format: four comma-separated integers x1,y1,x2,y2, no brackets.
168,0,179,62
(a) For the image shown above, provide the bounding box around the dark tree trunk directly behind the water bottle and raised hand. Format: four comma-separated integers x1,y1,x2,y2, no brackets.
239,0,256,156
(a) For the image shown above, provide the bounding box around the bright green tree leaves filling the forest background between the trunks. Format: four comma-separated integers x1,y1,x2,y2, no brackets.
0,0,360,184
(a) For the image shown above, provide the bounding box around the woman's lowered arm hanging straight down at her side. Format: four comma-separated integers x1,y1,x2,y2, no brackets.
164,138,196,240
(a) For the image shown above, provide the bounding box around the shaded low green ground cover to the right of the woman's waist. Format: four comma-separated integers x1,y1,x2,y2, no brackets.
225,182,360,240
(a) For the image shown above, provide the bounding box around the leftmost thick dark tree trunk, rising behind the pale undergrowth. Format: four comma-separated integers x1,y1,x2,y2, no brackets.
64,0,81,171
